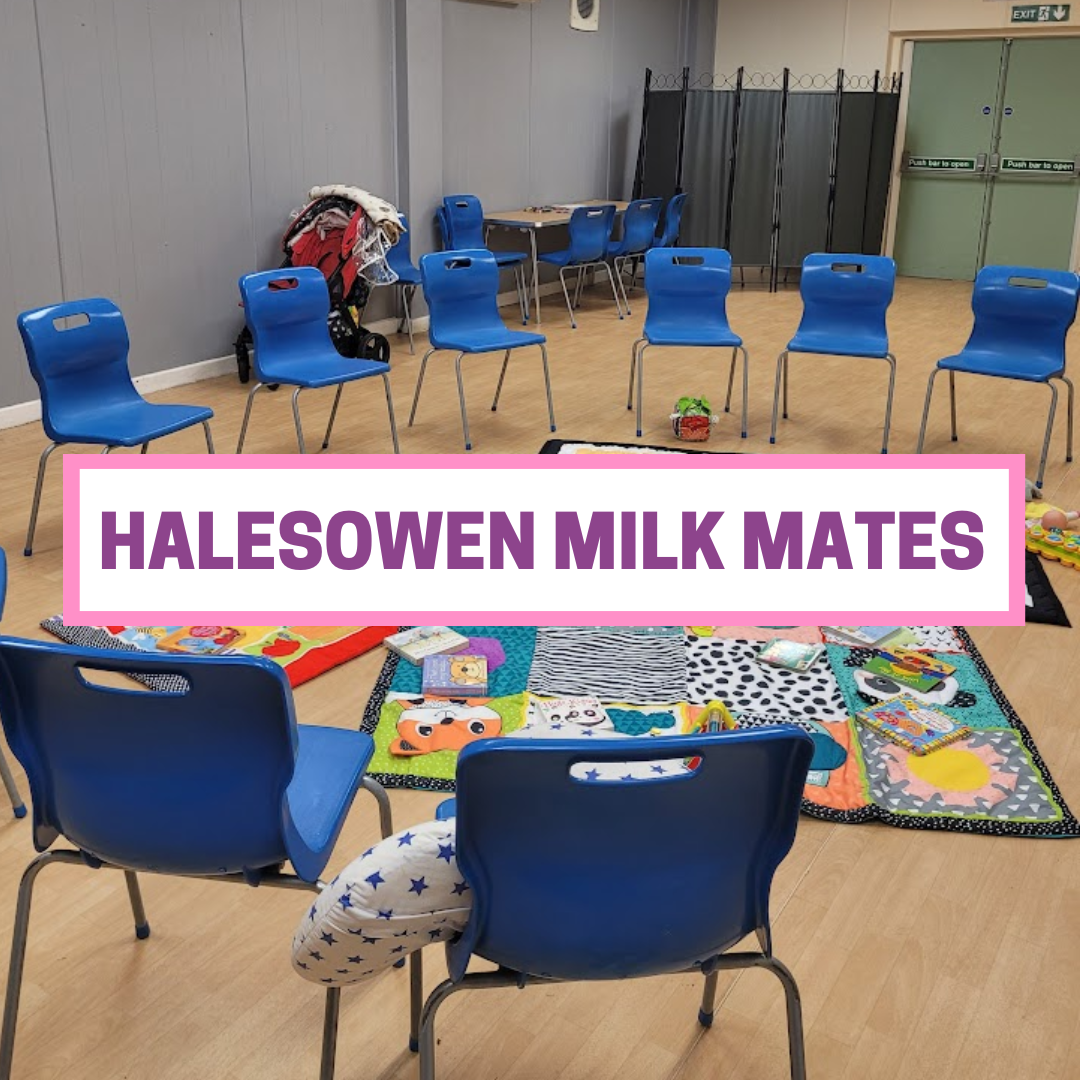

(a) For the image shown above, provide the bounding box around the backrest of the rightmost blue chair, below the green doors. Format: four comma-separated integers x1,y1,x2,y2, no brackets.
964,267,1080,369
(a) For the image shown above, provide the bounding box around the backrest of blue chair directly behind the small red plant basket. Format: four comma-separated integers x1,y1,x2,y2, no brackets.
645,247,731,330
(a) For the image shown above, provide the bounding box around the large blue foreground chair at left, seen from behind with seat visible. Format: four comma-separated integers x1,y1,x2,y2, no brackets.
0,637,393,1080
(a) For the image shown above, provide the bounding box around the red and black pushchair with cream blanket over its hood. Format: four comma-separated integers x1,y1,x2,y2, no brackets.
235,188,397,389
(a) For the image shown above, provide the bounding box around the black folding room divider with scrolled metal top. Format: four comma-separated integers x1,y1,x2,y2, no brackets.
634,68,901,291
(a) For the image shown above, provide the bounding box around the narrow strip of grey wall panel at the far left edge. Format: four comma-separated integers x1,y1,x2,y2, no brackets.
0,0,63,406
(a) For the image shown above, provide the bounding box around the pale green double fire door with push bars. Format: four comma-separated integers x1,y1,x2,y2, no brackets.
893,38,1080,281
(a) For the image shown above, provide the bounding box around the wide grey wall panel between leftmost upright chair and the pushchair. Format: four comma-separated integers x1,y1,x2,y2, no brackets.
38,0,253,374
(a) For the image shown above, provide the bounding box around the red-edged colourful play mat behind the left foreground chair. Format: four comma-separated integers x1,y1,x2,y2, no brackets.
41,615,397,690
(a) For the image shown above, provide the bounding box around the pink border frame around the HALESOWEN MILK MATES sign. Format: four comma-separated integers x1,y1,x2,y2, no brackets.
64,454,1026,626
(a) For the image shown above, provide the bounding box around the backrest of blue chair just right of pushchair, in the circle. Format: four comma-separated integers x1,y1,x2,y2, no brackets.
420,248,507,348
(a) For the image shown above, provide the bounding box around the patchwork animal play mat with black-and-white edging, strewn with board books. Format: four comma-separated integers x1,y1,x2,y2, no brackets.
362,626,1080,837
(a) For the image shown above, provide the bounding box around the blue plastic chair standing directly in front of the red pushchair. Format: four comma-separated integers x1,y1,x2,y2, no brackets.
237,267,401,454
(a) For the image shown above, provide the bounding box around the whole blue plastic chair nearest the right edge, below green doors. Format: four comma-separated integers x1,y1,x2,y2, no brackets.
916,267,1080,488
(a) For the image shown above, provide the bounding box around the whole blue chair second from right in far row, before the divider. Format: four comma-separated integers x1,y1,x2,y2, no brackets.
769,255,896,454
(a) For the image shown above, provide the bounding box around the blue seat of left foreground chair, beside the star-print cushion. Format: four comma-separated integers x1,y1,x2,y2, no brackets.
289,724,375,853
